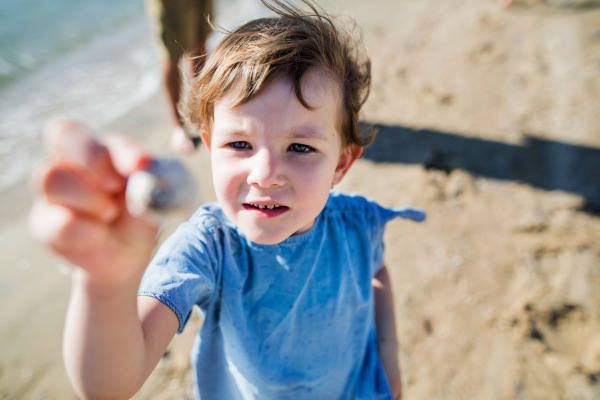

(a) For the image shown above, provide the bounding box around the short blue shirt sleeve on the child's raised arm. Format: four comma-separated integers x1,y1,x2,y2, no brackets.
138,220,221,333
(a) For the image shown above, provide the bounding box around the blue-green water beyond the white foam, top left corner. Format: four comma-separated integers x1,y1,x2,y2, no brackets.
0,0,143,88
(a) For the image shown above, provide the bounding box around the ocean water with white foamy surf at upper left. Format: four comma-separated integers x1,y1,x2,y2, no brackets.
0,0,284,195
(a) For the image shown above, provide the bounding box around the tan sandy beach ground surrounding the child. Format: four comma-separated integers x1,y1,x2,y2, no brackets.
0,0,600,400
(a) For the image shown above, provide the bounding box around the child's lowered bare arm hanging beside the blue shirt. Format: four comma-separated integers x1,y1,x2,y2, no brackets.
372,265,402,400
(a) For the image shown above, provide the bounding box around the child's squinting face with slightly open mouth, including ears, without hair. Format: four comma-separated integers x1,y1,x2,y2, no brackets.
203,73,360,244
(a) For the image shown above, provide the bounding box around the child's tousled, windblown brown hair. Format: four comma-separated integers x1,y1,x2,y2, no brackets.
180,0,375,148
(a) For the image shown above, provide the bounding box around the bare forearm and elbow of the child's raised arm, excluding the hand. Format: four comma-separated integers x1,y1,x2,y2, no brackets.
63,271,179,399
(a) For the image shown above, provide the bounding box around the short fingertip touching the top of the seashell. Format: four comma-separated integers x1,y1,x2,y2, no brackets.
104,133,152,176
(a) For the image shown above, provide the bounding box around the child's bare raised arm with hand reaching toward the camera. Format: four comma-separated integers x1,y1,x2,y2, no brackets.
29,121,179,399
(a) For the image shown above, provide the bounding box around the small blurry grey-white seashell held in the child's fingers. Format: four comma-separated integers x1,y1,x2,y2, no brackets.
125,159,198,222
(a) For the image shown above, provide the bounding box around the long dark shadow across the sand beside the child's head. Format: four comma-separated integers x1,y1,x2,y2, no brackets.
362,125,600,213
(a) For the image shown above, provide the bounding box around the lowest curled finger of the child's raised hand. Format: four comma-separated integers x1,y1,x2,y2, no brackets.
29,199,109,254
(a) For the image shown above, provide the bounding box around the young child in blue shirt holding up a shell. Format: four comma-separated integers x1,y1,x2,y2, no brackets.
30,0,424,400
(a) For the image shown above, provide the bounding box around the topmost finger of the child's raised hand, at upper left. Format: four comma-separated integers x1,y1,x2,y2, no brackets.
44,120,125,193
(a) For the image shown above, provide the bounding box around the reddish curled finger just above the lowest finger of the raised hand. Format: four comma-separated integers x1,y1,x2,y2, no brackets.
37,166,121,222
